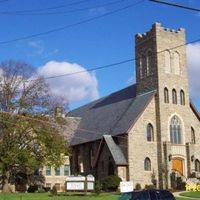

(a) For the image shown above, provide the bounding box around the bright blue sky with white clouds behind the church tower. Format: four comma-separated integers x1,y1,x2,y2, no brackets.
0,0,200,110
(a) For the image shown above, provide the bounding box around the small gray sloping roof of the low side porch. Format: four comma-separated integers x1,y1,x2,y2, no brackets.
103,135,128,165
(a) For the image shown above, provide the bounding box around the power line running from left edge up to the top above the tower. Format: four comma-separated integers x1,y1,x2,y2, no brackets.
0,0,145,45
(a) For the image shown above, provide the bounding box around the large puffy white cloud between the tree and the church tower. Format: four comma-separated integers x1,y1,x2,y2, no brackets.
38,61,99,103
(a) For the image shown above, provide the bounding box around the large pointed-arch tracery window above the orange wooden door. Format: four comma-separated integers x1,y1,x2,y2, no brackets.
170,116,182,144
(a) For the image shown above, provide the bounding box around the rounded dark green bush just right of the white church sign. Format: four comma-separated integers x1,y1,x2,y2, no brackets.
101,175,121,191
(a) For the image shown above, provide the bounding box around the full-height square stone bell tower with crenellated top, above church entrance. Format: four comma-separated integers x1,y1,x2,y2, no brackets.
135,23,190,188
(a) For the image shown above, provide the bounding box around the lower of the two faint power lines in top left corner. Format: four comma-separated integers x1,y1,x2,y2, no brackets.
0,0,126,16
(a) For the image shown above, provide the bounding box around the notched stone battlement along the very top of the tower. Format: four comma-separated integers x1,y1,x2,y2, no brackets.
135,22,185,42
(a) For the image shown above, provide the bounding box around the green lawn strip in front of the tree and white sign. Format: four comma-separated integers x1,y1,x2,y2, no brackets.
0,193,119,200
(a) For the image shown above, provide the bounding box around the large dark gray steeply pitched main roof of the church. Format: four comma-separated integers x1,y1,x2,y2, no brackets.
67,85,155,145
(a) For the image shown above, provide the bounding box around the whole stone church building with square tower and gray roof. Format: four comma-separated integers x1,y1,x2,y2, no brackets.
67,23,200,188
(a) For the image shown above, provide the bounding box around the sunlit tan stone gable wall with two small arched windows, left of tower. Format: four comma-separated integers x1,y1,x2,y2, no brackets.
128,98,158,187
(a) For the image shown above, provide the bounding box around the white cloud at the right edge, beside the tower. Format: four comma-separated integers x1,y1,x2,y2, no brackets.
187,43,200,99
